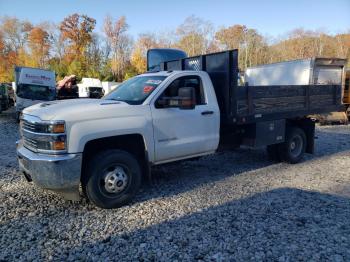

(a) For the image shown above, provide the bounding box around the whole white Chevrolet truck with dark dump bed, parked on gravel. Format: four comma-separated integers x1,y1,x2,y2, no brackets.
17,50,341,208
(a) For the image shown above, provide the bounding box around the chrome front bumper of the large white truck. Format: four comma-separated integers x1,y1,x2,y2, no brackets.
17,142,82,200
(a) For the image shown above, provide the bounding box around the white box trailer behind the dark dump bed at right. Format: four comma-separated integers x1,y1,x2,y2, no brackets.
244,58,344,86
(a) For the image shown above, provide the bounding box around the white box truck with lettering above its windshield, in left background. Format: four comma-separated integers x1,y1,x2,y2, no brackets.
14,67,56,120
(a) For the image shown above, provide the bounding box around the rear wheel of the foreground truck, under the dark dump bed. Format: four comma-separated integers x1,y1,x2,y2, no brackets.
278,127,307,164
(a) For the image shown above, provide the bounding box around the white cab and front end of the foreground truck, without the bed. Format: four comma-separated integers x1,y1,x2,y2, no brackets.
18,71,220,207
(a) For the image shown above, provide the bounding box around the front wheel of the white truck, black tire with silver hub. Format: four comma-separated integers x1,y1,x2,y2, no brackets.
82,150,141,208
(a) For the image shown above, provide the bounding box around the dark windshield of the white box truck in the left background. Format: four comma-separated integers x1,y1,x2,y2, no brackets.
16,84,56,101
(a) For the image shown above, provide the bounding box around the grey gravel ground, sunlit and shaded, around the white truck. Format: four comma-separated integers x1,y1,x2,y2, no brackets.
0,108,350,261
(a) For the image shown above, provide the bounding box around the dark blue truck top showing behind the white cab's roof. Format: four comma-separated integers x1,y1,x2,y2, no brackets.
147,48,187,71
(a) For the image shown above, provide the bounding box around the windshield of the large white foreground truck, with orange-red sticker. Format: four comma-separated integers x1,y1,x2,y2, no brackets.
103,76,166,105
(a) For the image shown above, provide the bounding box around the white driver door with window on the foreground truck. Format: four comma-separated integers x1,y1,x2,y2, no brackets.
151,75,219,162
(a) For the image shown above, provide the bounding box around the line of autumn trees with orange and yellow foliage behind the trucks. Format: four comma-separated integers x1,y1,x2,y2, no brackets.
0,13,350,82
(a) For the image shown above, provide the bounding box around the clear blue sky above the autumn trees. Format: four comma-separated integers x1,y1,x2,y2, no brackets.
0,0,350,37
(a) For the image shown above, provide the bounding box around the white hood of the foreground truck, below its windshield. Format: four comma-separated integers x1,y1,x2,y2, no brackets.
23,99,138,122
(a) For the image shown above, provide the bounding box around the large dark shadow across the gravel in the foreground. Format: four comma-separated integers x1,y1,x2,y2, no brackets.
0,188,350,261
